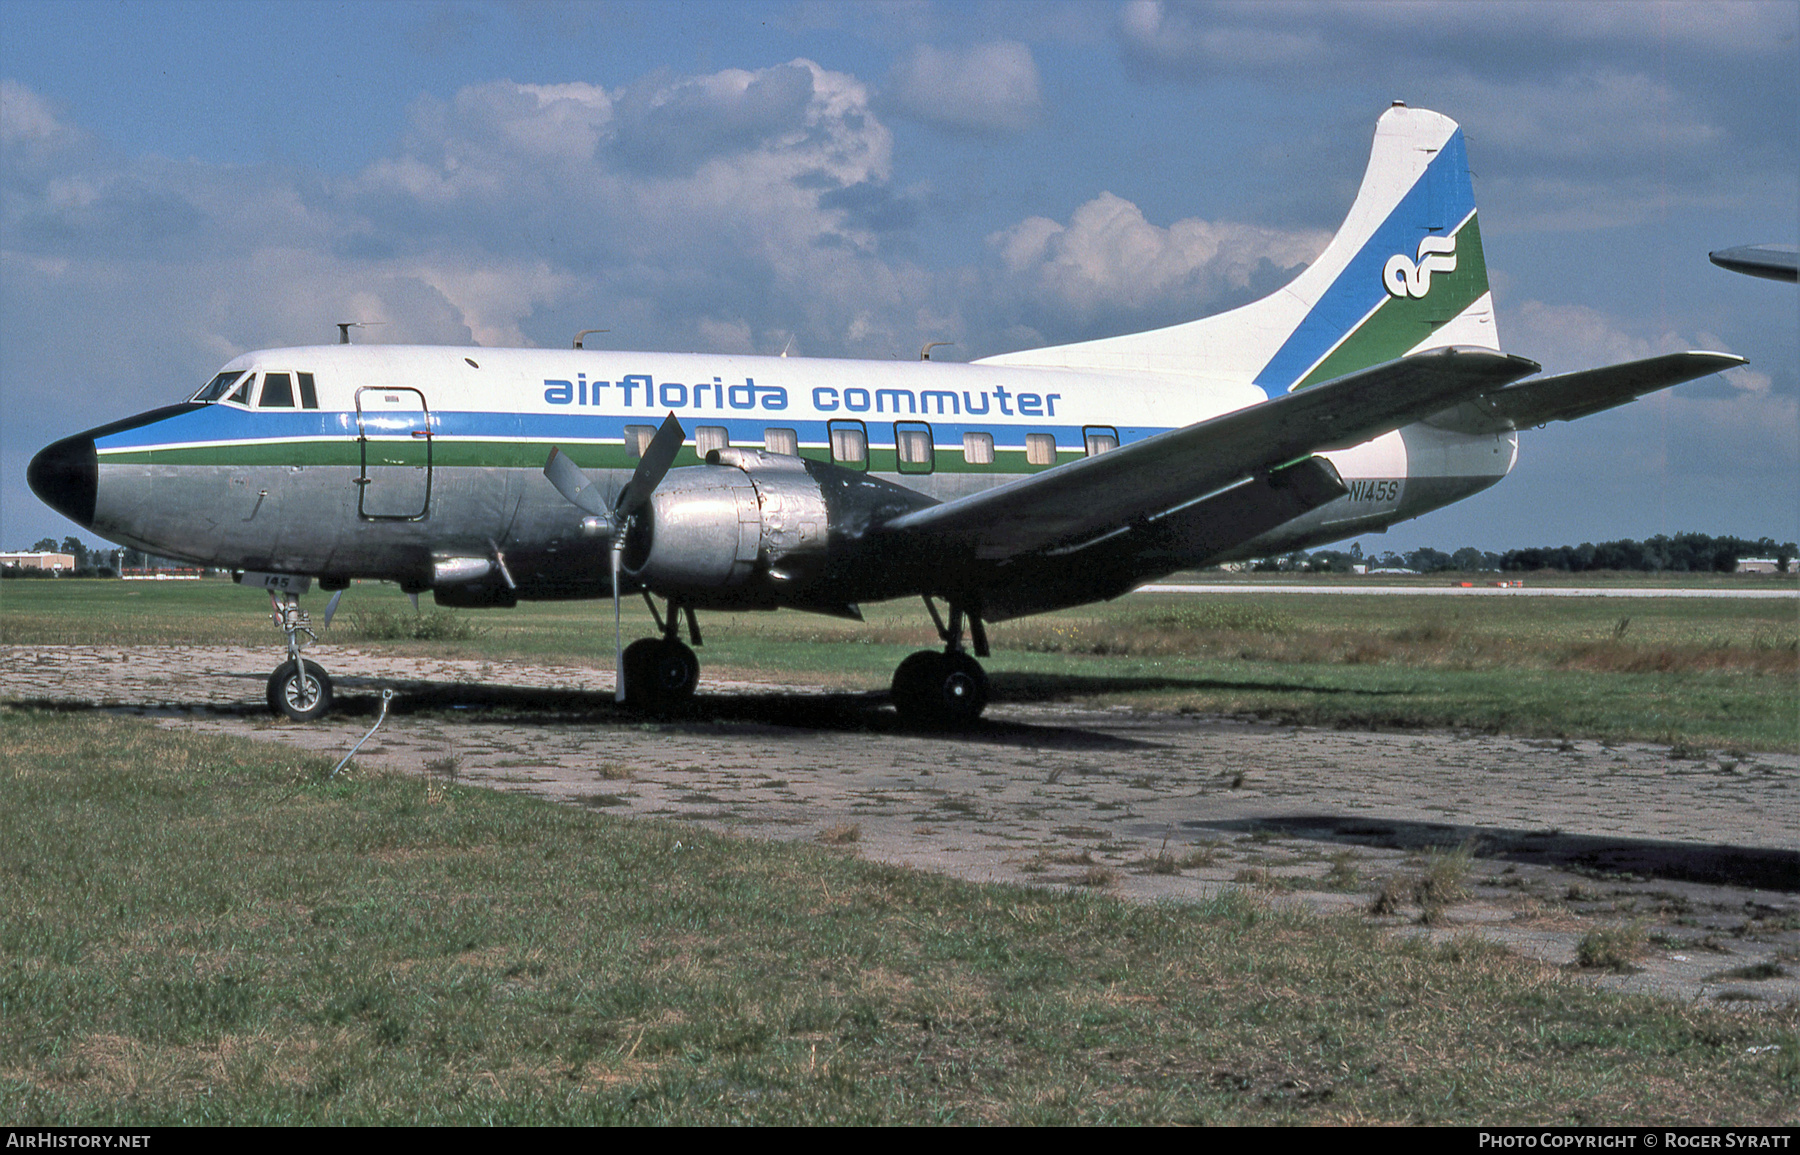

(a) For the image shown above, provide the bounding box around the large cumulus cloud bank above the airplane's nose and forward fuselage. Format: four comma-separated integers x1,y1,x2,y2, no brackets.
0,61,934,390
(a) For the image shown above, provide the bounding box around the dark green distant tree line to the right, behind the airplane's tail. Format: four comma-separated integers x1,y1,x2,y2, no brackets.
1253,533,1800,574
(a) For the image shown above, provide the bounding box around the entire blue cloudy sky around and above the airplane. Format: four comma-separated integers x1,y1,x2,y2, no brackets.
0,0,1800,551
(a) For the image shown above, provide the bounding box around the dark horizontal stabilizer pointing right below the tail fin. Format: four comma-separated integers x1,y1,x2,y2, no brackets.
1427,353,1744,434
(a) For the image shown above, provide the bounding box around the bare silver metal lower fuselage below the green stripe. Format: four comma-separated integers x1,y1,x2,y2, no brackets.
92,413,1517,608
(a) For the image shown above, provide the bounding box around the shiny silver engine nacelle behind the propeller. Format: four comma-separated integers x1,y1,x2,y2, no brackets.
623,450,830,594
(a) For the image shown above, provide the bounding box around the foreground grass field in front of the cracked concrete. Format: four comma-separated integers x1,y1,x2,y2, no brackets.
0,709,1800,1126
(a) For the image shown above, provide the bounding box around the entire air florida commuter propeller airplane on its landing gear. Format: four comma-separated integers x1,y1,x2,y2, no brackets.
29,104,1744,723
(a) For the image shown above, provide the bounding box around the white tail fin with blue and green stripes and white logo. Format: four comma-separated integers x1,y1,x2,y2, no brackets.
983,104,1499,396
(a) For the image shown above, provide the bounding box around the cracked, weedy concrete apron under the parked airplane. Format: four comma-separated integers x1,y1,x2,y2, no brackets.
0,646,1800,1006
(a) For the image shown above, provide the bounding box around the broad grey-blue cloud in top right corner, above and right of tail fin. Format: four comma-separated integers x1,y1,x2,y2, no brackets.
1116,0,1800,230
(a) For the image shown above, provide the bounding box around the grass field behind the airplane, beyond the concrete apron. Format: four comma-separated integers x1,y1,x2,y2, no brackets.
0,574,1800,750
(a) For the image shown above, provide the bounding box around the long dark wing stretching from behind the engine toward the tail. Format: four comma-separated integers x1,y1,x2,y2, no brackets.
882,349,1537,561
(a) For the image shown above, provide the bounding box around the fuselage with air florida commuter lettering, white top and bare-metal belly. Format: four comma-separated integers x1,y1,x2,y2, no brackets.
32,345,1516,604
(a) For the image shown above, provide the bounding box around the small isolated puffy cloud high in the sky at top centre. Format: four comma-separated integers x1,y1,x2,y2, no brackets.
887,40,1044,135
